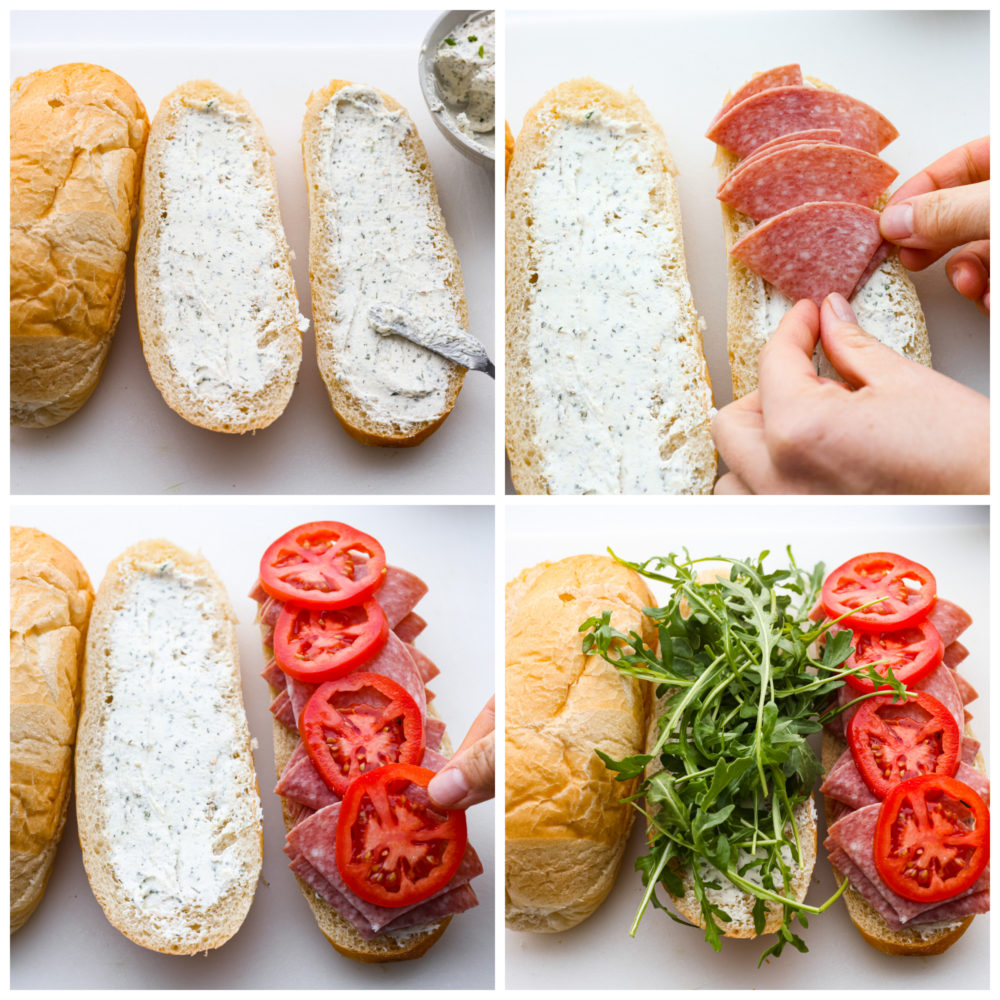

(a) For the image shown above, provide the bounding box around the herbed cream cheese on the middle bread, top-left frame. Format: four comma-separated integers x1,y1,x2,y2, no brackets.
157,98,309,420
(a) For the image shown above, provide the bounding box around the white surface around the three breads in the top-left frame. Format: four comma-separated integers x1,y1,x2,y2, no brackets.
11,11,495,495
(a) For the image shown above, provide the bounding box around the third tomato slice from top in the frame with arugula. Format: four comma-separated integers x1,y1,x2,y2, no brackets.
847,691,962,799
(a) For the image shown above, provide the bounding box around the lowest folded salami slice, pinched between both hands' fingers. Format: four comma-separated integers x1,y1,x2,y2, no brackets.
730,201,882,306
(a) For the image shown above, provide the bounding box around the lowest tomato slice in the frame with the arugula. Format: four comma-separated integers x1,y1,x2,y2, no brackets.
875,774,990,903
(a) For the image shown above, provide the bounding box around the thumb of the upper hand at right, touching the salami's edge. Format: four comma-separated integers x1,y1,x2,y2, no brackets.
880,181,990,250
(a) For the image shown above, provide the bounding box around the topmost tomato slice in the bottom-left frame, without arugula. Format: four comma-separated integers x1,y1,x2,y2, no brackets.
260,521,385,608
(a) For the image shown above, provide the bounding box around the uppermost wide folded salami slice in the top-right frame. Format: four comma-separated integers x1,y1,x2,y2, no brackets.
706,86,899,157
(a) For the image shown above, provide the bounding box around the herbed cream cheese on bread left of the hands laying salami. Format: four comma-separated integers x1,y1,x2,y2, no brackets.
526,108,712,494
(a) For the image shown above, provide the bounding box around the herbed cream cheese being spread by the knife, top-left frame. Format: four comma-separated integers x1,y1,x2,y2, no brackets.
318,85,458,429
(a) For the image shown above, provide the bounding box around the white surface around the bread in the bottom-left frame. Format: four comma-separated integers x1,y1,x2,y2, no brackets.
10,505,497,991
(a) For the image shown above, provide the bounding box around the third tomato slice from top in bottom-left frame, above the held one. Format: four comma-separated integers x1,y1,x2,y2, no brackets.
299,673,424,795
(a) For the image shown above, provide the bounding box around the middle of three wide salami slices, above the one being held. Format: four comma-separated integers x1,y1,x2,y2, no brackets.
718,143,899,222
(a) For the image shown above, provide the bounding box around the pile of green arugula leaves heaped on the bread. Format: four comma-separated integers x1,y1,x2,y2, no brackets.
580,548,906,967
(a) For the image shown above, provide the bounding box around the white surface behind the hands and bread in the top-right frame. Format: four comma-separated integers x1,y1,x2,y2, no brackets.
504,10,989,493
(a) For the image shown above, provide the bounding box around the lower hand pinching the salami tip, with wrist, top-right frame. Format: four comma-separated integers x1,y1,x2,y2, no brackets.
712,294,990,494
